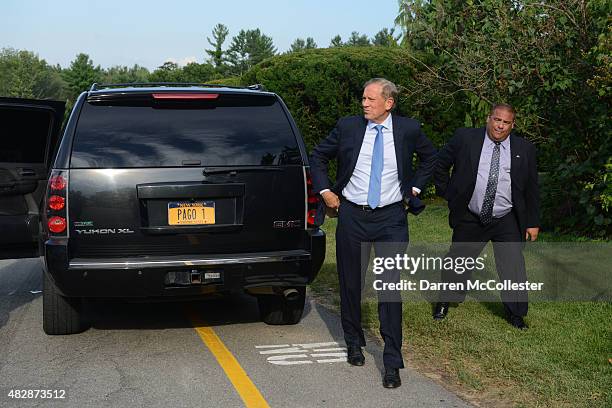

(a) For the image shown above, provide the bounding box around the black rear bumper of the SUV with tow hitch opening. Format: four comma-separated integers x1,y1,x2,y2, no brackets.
45,229,325,297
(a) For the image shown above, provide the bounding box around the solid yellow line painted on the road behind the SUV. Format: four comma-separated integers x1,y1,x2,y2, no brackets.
192,319,270,408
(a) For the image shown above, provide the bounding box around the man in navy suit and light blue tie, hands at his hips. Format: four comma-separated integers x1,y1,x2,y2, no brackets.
310,78,436,388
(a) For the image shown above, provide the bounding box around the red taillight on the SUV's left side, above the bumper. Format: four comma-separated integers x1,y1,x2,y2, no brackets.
43,170,69,237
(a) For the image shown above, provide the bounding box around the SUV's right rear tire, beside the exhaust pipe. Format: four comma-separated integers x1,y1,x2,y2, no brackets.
257,287,306,325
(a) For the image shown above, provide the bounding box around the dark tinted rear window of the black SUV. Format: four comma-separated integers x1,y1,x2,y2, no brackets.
71,94,301,168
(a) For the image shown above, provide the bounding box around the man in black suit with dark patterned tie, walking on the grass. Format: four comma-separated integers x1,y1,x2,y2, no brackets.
434,104,540,329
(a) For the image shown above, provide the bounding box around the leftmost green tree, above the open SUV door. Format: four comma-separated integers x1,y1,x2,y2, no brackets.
0,48,66,100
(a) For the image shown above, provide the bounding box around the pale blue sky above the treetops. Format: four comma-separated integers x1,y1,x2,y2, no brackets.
0,0,399,70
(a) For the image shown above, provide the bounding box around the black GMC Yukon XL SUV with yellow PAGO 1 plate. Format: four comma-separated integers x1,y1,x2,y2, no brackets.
2,84,325,334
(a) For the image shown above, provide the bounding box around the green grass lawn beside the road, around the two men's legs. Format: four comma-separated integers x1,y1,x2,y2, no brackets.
311,201,612,407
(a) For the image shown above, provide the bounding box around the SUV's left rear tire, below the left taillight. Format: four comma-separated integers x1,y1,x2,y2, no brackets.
43,271,84,335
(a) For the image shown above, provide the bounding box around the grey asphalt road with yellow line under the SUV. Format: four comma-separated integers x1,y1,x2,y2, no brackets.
0,259,468,408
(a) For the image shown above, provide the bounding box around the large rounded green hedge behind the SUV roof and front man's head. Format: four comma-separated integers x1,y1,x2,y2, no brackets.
242,47,414,153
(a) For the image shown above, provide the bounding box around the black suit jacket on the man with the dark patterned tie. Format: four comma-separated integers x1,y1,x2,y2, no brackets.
434,128,540,239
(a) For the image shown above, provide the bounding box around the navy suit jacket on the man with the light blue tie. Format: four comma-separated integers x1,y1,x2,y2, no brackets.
310,115,436,225
